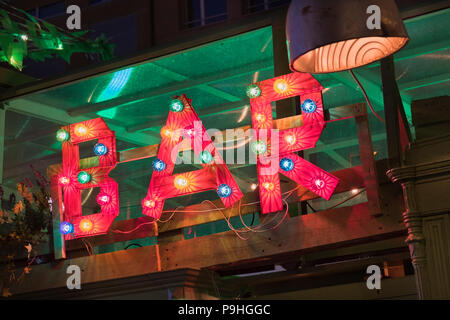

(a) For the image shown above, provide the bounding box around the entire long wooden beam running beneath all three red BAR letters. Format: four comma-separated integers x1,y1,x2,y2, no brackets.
13,203,405,293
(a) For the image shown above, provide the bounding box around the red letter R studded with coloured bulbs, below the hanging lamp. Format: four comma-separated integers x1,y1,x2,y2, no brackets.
249,73,339,213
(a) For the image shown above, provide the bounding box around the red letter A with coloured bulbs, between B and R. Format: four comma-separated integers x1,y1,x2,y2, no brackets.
142,95,243,219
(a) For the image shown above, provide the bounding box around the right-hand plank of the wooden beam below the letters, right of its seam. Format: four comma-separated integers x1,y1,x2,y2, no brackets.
160,203,405,271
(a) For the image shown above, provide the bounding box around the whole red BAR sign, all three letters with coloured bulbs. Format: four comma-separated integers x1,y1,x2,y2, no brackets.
51,72,339,240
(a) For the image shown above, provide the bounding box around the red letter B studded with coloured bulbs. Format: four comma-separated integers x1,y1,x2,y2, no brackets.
58,118,119,240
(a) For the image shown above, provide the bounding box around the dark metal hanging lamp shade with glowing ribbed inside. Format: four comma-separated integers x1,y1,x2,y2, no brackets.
286,0,409,73
